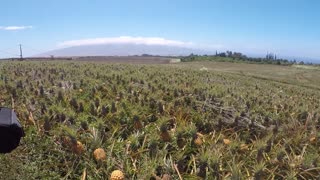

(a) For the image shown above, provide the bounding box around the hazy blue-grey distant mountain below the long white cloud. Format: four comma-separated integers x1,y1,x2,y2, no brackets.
37,44,213,56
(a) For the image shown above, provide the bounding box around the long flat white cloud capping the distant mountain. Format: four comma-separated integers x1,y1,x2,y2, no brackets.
58,36,193,47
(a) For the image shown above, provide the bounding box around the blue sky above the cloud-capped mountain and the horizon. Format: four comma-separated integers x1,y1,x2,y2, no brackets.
0,0,320,59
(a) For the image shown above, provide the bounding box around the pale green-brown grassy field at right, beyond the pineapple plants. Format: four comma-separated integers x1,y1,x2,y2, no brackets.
180,61,320,89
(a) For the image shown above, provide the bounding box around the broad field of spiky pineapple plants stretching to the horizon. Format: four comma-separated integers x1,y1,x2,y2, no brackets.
0,61,320,180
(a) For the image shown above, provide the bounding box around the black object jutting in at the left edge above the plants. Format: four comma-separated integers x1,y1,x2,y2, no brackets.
0,107,24,153
